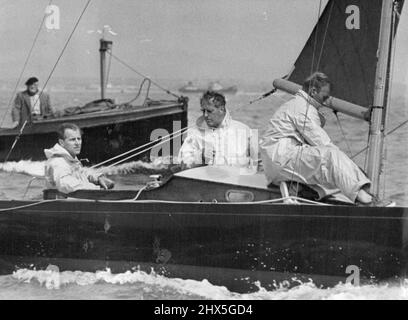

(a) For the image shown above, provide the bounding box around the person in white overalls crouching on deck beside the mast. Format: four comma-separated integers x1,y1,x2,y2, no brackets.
260,72,373,204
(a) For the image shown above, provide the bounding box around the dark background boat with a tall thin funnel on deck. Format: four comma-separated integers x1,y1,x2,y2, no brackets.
0,39,188,164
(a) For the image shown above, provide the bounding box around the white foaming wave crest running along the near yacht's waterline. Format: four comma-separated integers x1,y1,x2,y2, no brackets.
7,267,408,300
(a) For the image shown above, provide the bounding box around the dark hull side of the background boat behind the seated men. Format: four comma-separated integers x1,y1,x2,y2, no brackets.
0,105,187,164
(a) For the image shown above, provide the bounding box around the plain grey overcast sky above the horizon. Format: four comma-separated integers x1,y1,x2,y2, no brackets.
0,0,408,82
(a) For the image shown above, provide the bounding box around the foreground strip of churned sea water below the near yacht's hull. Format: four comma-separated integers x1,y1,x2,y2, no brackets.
0,269,408,300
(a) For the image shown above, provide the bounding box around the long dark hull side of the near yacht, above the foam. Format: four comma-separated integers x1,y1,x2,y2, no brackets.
0,200,408,292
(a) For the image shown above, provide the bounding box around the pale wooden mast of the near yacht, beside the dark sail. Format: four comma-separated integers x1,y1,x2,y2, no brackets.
367,0,394,197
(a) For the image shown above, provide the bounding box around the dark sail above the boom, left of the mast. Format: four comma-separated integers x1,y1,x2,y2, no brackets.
289,0,403,107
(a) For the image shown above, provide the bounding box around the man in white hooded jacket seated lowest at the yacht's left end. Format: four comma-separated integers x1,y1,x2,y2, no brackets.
44,123,114,193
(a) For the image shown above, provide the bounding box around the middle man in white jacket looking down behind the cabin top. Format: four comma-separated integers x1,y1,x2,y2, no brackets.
179,91,258,168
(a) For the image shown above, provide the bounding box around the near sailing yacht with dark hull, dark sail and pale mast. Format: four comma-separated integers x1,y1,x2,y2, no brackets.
0,0,408,292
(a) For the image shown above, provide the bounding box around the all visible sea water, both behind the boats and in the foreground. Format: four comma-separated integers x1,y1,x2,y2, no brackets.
0,85,408,300
